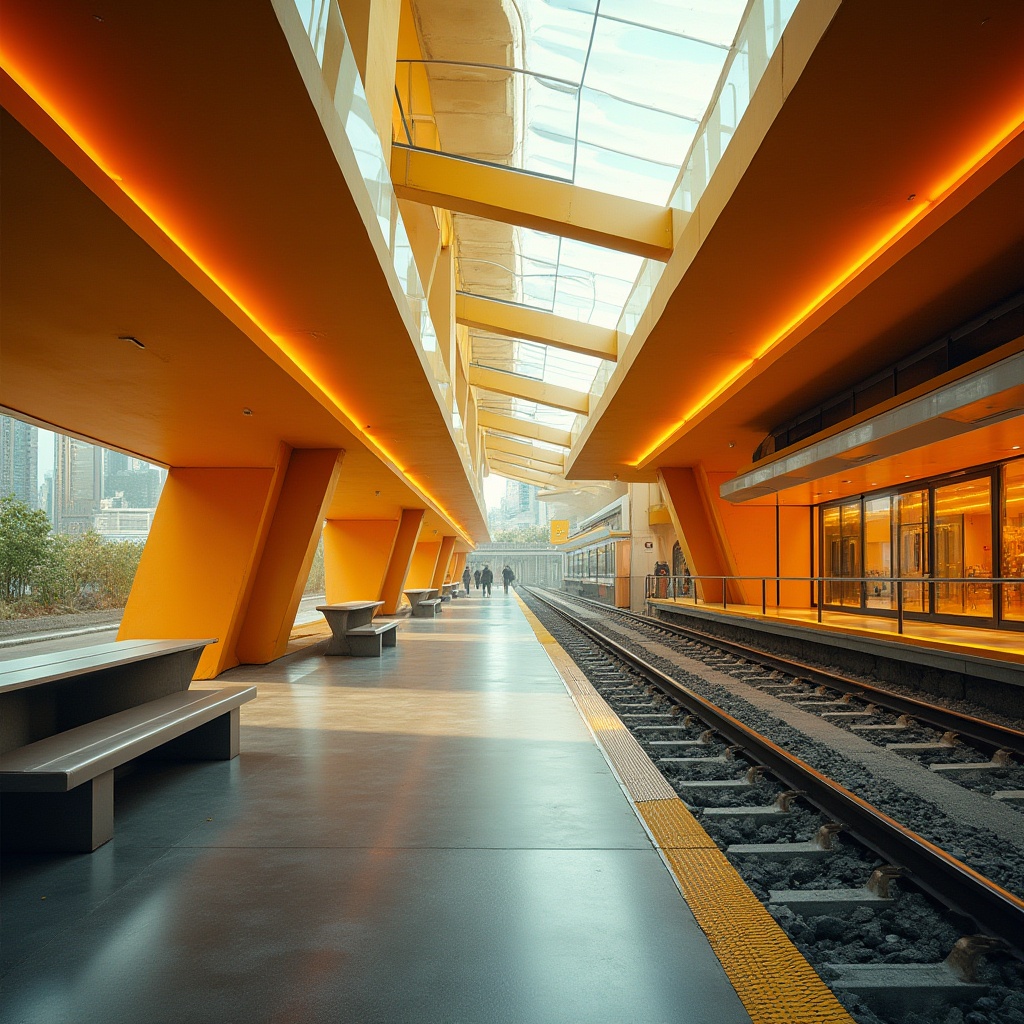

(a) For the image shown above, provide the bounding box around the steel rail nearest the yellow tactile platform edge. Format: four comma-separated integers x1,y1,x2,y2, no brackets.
524,588,1024,951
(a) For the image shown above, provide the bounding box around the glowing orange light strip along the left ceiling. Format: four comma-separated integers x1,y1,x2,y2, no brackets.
0,53,472,543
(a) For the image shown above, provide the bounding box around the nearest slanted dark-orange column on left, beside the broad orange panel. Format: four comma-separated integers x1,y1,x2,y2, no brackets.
237,449,344,665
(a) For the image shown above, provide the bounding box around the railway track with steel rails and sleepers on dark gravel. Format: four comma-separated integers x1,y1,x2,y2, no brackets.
527,591,1024,1021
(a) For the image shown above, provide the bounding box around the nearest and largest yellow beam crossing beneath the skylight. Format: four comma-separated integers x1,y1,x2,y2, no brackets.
391,145,672,262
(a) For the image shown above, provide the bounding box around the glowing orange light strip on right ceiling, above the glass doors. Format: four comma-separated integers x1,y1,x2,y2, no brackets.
630,105,1024,467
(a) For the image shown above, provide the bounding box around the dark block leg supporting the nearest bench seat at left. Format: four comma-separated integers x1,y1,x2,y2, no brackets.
0,771,114,853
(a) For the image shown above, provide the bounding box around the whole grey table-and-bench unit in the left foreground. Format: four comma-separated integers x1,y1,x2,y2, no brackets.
0,640,256,852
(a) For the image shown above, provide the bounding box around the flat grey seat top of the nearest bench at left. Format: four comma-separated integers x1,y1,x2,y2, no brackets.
0,686,256,793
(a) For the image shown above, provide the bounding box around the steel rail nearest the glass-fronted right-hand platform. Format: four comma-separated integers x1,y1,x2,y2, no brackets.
536,595,1024,757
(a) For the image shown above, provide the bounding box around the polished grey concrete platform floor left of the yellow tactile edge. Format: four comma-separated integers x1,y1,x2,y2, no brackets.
0,593,750,1024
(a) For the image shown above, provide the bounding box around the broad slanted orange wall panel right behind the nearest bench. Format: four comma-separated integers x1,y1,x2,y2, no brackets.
118,466,284,679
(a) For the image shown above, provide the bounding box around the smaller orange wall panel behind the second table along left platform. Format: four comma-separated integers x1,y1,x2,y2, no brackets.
324,519,398,604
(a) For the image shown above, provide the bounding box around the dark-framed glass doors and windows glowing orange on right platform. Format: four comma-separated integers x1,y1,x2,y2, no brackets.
819,459,1024,629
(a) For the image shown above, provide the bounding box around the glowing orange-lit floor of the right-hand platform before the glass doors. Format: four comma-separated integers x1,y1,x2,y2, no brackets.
652,597,1024,663
